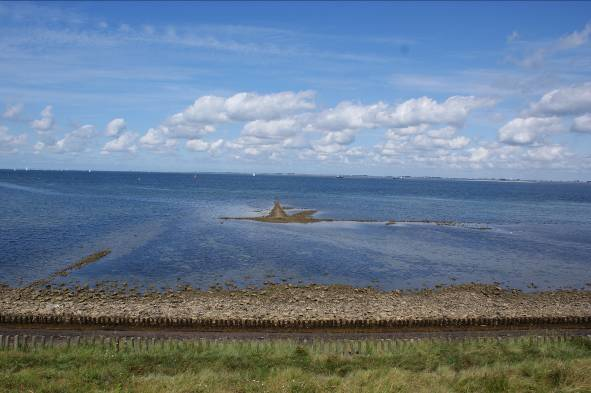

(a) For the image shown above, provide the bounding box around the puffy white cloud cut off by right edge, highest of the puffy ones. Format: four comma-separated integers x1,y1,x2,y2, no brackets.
530,83,591,116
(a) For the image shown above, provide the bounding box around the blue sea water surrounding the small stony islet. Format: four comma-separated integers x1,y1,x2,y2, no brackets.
0,170,591,289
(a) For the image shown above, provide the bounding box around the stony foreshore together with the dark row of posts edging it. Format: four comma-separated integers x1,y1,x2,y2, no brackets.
0,284,591,328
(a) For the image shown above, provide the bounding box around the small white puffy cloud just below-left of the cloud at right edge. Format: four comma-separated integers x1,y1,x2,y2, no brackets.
498,116,566,145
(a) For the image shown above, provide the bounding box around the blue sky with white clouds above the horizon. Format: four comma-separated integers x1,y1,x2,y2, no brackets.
0,2,591,180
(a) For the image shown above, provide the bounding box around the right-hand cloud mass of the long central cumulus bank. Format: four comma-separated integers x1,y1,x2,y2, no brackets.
306,96,494,159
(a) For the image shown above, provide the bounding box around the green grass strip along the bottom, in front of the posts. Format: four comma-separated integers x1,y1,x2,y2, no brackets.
0,338,591,393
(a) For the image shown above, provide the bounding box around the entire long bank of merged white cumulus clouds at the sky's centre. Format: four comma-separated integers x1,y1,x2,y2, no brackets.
139,91,494,159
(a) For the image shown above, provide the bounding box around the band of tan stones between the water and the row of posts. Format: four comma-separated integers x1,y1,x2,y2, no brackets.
0,284,591,320
